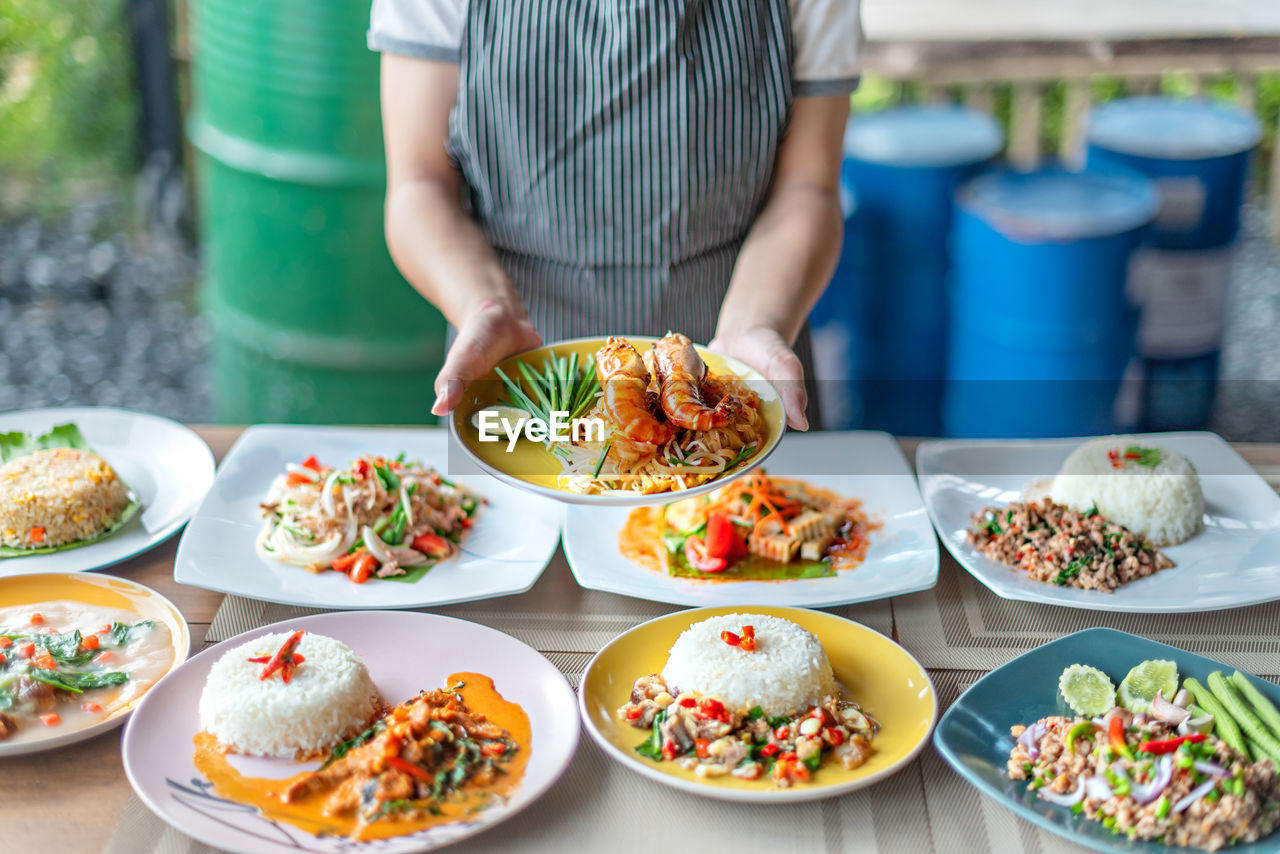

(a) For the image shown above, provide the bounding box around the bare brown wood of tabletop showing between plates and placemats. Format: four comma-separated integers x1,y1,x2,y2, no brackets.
10,426,1280,854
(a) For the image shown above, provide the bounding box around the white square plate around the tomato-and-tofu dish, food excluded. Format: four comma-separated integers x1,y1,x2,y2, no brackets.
564,433,938,608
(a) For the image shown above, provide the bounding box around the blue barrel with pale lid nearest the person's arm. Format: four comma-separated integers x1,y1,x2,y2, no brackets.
828,105,1004,435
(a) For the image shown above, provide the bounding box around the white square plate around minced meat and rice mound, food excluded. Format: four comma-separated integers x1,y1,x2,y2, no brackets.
915,433,1280,613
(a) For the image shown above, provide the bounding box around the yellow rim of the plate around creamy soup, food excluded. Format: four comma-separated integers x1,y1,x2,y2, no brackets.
0,572,191,757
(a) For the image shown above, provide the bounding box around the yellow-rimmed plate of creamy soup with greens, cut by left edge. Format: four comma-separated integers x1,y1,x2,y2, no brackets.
0,572,191,758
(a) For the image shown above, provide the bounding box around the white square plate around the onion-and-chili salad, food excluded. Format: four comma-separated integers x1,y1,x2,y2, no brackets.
173,425,563,608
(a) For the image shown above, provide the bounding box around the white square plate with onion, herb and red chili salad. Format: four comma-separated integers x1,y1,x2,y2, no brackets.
174,425,563,609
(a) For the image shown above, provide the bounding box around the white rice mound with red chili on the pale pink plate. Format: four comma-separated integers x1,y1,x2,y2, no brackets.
200,631,383,758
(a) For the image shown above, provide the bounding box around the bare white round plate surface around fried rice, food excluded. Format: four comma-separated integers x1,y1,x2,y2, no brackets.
0,406,214,575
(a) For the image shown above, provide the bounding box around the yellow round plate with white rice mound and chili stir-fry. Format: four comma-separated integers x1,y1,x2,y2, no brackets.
579,606,937,804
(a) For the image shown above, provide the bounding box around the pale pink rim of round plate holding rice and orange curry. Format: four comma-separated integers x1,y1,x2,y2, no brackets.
120,611,581,854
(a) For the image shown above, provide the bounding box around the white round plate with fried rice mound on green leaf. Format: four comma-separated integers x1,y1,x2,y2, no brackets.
0,406,214,576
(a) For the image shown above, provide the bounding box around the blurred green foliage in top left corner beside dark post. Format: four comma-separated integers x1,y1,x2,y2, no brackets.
0,0,137,207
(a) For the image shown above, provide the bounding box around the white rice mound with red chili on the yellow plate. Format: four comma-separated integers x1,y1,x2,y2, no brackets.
662,613,837,716
